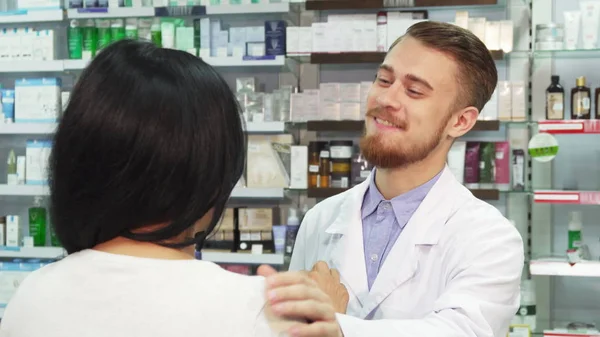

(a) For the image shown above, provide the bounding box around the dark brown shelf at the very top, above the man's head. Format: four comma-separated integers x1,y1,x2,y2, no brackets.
305,0,498,11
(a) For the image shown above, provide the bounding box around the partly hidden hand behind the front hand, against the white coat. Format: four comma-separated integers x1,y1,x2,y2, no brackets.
308,261,350,314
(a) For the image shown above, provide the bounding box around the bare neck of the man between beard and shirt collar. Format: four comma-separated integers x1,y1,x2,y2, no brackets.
375,158,446,200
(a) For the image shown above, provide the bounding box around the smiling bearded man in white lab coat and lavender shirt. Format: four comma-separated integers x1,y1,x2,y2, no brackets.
260,22,524,337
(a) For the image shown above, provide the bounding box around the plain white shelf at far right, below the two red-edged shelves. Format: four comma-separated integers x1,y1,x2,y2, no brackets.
529,258,600,277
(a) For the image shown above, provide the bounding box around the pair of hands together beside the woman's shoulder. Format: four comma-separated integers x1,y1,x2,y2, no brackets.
258,261,349,337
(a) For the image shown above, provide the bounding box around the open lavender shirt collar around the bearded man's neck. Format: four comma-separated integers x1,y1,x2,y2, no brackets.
361,169,443,220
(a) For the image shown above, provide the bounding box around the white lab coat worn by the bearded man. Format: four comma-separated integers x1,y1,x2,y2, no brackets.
290,167,524,337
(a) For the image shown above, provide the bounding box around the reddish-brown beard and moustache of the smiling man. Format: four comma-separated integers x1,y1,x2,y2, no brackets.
360,108,451,169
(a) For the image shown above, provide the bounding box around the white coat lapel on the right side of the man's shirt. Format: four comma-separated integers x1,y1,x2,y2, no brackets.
363,167,456,315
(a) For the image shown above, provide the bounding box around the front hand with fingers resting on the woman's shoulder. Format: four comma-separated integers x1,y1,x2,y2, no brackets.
258,266,343,337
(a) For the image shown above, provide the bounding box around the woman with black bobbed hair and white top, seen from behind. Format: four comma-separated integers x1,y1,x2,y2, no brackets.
0,41,342,337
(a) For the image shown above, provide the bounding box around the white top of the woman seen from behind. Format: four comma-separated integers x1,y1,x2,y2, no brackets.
0,250,290,337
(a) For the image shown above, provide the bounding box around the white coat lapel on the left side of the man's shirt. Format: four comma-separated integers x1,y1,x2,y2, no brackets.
326,179,369,309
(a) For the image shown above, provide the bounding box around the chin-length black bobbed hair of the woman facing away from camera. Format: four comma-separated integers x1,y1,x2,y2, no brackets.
49,40,246,253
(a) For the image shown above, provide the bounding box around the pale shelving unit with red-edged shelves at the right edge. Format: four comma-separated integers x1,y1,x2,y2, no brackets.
529,0,600,330
